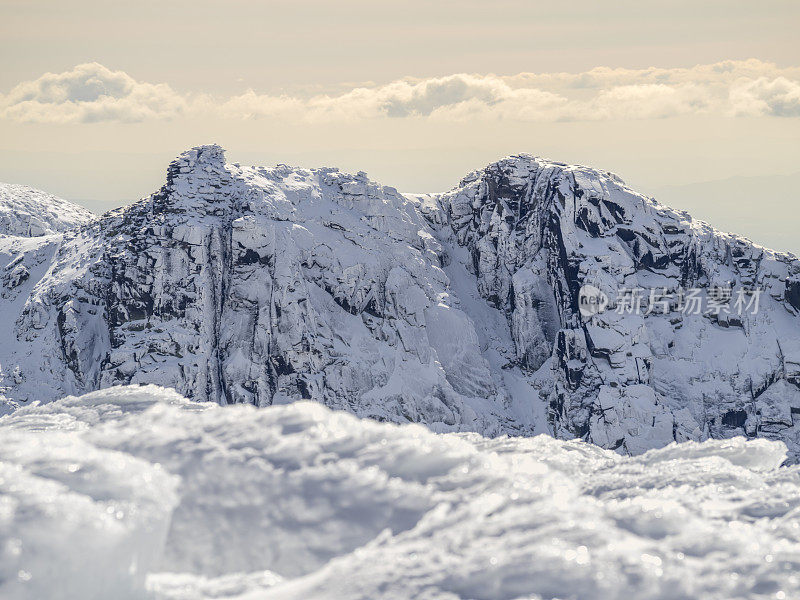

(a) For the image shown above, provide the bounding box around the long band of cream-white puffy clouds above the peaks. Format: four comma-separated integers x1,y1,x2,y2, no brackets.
0,59,800,123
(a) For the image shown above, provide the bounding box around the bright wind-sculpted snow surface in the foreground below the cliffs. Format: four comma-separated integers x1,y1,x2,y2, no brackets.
0,386,800,600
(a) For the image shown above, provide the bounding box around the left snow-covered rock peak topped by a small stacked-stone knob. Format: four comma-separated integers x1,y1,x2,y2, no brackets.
0,146,512,432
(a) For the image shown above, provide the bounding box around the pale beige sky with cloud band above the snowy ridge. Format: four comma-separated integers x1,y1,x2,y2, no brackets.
0,0,800,253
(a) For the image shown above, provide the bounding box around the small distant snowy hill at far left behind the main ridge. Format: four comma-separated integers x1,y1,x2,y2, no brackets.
0,183,97,237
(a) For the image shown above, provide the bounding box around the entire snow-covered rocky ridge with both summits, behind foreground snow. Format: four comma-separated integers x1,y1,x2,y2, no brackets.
0,146,800,454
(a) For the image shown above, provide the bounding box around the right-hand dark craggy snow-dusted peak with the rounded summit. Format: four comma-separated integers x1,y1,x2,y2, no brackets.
441,156,800,452
